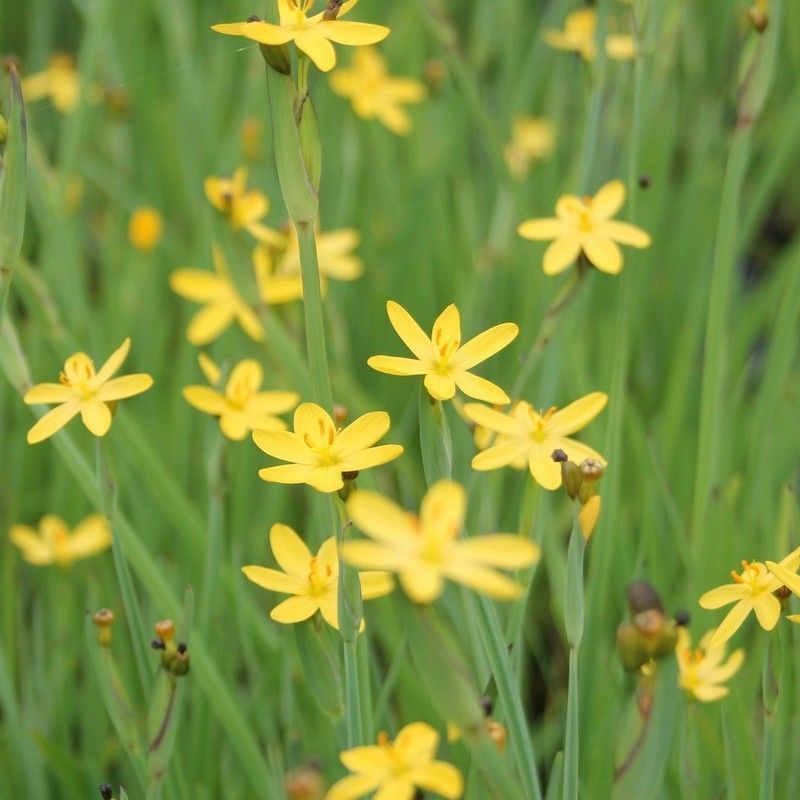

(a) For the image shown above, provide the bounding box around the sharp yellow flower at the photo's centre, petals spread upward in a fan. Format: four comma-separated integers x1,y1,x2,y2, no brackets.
367,300,519,404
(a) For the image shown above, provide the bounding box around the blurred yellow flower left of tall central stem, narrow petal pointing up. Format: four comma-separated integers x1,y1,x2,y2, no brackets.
169,246,264,345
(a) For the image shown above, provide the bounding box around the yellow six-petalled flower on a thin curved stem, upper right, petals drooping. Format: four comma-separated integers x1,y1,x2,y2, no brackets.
517,181,650,275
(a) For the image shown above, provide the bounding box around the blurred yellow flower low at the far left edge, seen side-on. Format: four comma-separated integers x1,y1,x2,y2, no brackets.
9,514,111,567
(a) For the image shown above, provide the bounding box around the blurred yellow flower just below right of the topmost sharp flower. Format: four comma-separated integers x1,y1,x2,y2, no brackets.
331,47,427,136
